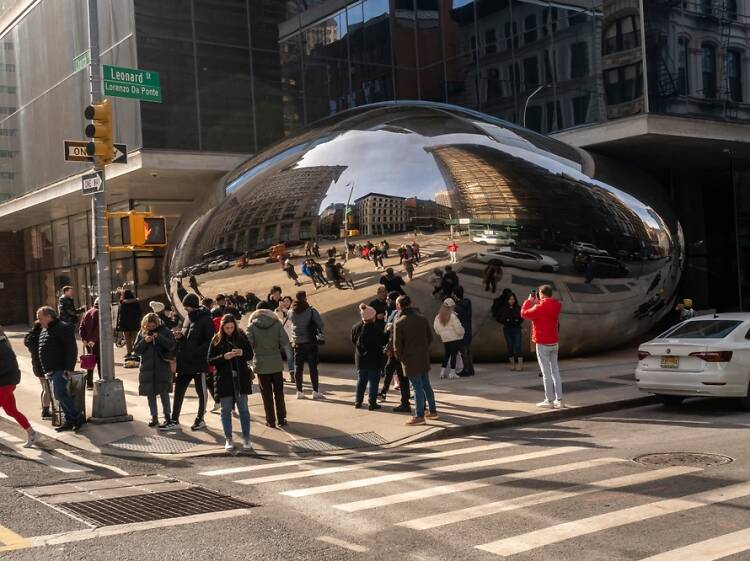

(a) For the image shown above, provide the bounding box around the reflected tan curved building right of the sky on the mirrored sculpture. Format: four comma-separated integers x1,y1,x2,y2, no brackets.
425,145,649,250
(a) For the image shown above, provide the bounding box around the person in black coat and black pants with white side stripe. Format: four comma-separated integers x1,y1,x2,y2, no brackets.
172,294,214,430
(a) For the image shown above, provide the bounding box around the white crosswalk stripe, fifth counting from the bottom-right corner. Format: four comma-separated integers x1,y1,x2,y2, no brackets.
281,446,582,498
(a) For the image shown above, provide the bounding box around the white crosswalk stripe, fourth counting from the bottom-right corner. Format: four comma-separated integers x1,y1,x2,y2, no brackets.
334,458,626,512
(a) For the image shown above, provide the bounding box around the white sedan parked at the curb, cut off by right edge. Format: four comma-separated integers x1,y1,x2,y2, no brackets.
635,313,750,410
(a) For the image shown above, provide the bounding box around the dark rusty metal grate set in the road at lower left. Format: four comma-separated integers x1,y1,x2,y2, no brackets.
57,487,256,526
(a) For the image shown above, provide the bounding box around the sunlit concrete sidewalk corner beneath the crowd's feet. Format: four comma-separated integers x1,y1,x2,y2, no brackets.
0,328,650,458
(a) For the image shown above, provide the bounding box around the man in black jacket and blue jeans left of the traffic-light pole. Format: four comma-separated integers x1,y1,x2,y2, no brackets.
36,306,84,432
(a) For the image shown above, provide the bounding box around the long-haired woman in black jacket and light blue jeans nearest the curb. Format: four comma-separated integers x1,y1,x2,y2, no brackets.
208,314,253,451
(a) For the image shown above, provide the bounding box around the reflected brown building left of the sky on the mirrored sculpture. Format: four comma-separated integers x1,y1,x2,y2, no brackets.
201,166,346,251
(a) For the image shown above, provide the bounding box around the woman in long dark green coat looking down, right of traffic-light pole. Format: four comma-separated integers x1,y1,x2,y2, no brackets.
133,313,177,430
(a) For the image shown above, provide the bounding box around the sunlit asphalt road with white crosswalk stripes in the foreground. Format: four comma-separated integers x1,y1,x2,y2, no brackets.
0,400,750,561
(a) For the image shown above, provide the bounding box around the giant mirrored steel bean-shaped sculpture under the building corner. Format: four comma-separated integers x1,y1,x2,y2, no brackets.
168,102,684,361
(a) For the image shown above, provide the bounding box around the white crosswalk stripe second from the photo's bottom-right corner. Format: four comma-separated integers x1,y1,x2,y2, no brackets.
476,482,750,557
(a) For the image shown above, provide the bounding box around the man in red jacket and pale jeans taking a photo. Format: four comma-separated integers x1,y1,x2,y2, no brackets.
521,284,564,409
